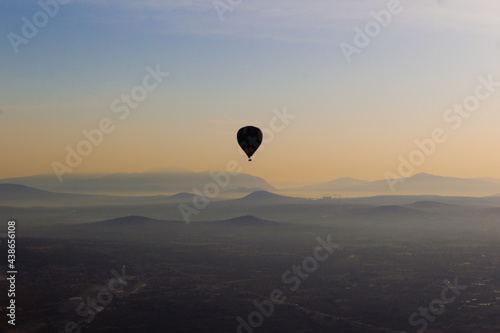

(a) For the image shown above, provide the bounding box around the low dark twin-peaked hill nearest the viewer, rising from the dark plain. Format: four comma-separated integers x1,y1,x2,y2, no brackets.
42,215,290,243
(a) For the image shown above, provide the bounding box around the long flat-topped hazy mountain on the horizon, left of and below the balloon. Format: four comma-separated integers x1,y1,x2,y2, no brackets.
0,169,275,195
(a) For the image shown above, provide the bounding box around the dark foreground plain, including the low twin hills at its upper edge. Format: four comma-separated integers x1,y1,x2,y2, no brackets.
0,216,500,333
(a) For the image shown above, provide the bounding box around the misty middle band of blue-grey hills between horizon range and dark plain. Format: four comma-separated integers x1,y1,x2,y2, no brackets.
0,184,500,228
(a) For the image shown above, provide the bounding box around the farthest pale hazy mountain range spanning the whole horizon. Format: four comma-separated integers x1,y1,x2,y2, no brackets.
0,169,500,197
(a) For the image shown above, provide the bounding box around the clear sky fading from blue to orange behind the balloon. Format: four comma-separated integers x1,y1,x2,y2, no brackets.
0,0,500,183
